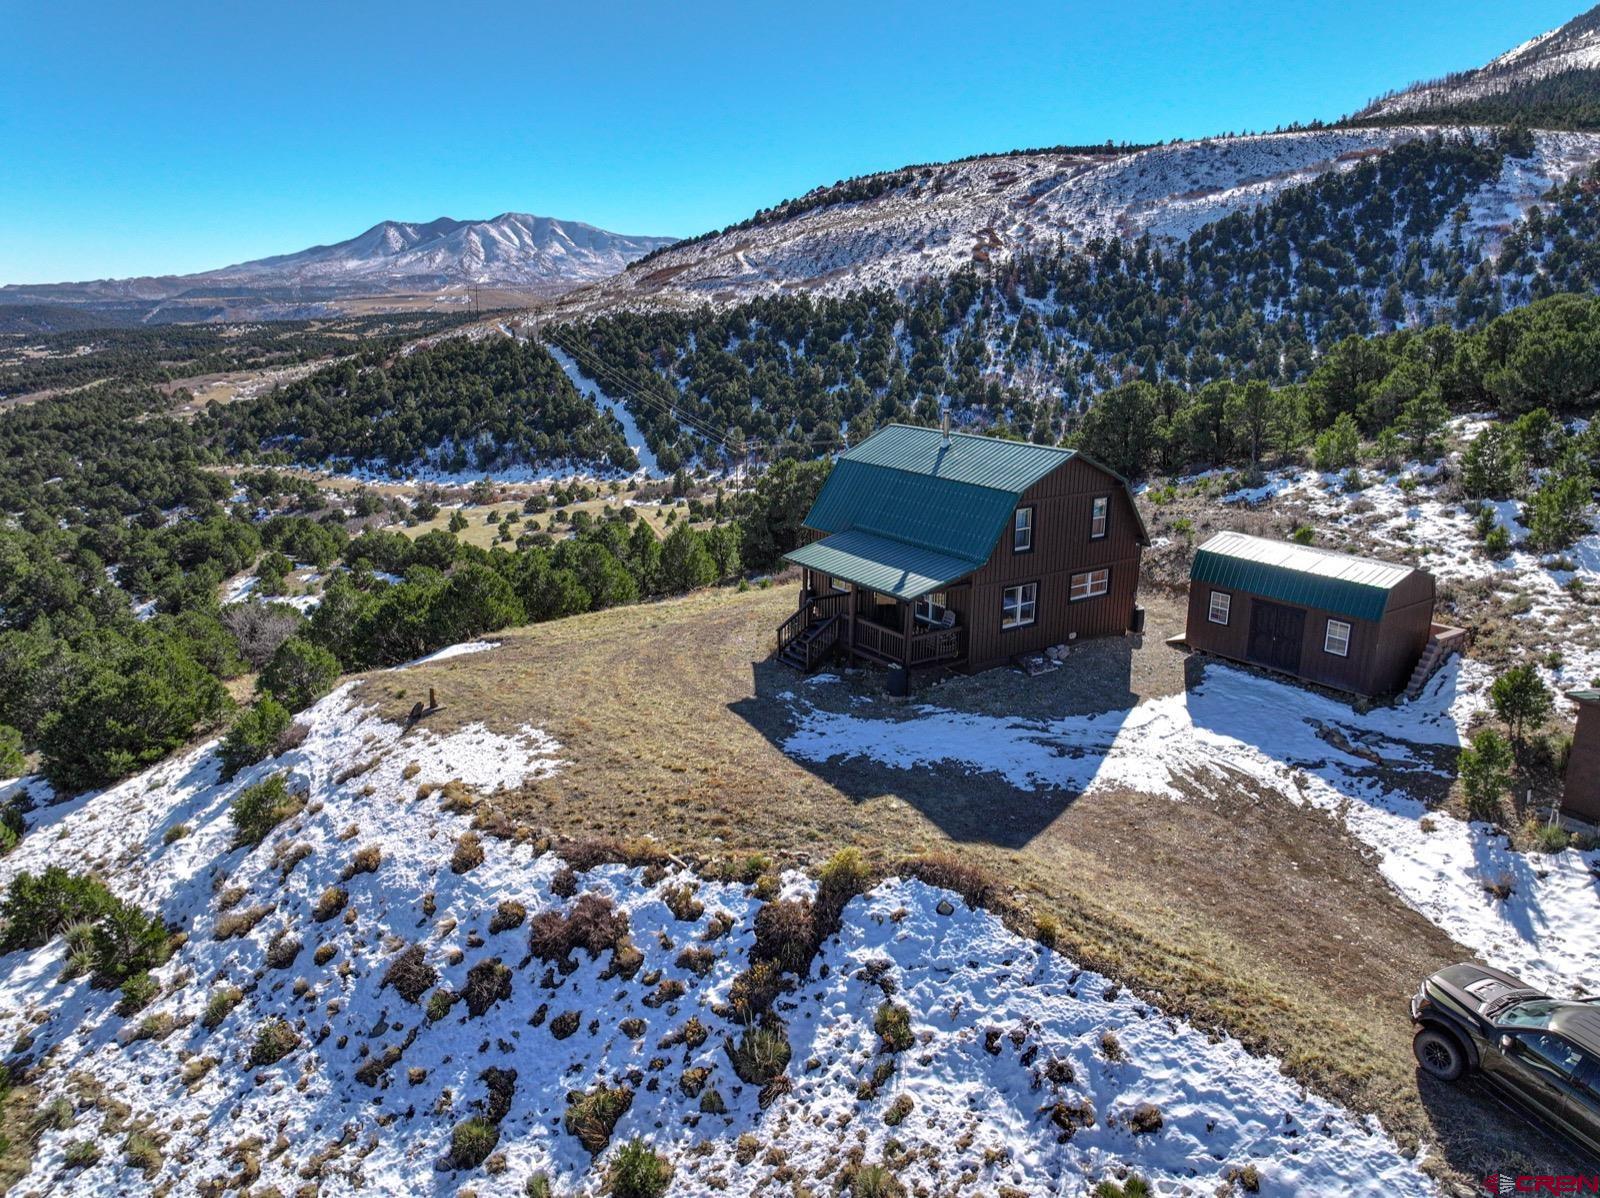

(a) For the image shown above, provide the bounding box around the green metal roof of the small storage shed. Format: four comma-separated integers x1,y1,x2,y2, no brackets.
1189,533,1413,621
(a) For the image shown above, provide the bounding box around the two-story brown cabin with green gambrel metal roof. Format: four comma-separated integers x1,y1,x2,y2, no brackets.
778,424,1149,672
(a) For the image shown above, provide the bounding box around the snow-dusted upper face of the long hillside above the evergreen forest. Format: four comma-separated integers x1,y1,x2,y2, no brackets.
568,125,1600,309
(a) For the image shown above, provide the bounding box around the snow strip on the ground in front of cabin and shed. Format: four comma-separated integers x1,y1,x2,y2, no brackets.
784,659,1600,995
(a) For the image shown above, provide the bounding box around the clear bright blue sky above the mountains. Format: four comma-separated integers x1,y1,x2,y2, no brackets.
0,0,1582,283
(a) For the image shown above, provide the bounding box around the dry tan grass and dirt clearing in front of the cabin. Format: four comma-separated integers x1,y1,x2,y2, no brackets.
363,585,1593,1184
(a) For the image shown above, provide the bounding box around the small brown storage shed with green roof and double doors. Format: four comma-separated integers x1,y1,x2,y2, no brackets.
1184,533,1435,696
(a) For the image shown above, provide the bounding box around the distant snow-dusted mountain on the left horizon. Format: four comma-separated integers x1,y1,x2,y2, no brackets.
0,213,672,315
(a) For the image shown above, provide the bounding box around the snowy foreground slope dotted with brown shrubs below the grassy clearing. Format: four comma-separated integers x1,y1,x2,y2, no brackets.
0,668,1434,1198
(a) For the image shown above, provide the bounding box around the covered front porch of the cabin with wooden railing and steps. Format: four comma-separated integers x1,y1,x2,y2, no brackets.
778,529,978,673
